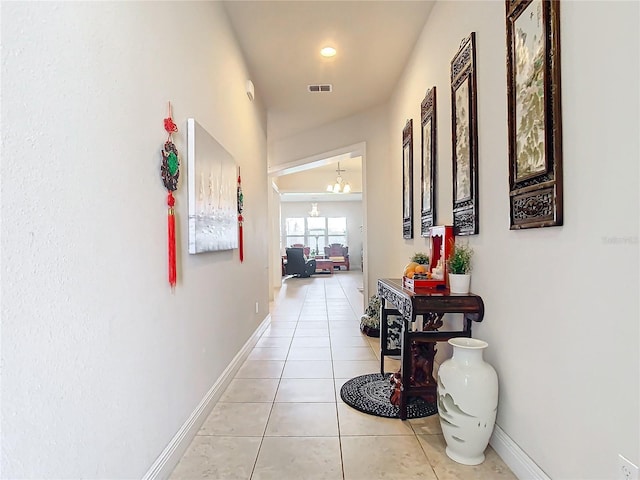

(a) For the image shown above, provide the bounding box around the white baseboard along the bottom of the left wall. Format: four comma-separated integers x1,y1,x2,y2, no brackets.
142,315,271,480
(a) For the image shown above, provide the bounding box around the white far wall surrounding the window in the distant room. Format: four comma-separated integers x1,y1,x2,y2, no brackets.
280,202,363,270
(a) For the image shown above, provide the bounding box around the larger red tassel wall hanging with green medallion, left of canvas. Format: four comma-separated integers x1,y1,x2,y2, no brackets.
160,102,180,290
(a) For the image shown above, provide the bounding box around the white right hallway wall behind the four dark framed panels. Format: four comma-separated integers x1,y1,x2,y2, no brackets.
388,1,640,480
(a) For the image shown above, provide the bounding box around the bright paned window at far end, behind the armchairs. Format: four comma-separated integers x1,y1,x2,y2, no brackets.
284,217,347,254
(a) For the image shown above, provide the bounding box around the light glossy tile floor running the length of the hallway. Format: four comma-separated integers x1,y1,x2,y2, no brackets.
171,271,516,480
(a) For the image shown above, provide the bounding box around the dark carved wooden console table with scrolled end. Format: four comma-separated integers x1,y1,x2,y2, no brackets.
378,278,484,420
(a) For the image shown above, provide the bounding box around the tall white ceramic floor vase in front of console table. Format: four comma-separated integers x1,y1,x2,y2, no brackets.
438,338,498,465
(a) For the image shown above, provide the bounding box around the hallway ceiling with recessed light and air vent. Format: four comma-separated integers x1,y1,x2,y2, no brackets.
223,0,434,141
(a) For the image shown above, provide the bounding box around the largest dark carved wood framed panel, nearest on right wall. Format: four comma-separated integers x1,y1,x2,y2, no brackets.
506,0,563,230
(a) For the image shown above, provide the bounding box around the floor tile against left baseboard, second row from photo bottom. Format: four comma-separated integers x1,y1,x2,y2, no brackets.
198,402,272,437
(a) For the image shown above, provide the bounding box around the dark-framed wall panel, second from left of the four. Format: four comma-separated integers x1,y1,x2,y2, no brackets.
420,86,437,237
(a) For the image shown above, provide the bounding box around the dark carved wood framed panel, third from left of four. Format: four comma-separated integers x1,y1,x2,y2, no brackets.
451,32,479,235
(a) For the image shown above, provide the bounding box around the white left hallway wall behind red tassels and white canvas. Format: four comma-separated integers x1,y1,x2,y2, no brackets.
0,2,268,479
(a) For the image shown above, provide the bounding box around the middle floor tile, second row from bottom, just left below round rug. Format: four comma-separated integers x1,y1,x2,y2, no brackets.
265,403,338,437
